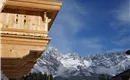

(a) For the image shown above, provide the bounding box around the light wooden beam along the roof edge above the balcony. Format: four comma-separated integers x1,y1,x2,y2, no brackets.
6,0,62,10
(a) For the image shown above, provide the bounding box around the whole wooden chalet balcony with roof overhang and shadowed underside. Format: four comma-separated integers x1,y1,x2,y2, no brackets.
0,0,62,78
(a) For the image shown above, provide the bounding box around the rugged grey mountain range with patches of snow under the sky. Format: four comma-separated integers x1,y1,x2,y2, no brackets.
32,47,130,80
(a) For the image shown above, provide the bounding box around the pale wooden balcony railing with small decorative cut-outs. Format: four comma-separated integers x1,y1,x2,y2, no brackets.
0,10,51,37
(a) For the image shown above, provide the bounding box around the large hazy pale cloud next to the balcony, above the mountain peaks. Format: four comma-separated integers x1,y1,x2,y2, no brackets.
49,0,106,54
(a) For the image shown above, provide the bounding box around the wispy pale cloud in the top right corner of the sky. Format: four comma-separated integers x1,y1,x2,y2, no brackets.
111,0,130,27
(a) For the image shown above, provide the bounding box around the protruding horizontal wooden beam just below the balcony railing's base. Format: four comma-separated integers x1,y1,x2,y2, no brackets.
0,36,50,47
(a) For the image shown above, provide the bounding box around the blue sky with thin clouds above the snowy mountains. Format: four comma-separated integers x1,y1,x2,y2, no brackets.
49,0,130,56
